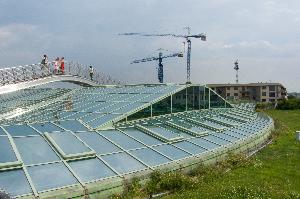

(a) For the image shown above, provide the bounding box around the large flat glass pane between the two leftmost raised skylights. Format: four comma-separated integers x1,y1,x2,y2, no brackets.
14,136,59,164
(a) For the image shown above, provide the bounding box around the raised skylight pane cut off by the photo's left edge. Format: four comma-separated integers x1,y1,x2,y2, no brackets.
0,136,17,163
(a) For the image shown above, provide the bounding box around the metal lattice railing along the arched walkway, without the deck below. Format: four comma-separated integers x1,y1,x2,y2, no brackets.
0,62,121,86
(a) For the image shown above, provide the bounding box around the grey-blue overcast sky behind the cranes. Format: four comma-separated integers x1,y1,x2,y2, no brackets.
0,0,300,92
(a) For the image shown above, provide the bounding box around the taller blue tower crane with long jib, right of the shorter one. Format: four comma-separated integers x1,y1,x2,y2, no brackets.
119,27,206,84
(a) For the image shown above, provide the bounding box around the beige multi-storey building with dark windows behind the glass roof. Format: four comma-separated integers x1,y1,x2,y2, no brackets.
207,83,287,102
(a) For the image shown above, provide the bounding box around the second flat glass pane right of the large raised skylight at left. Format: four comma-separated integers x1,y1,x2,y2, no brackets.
100,131,144,150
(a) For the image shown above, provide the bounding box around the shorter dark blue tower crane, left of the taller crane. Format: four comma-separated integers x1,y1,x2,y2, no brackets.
131,52,183,83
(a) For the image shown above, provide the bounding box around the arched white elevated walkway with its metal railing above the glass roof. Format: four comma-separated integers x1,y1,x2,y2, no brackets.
0,62,120,94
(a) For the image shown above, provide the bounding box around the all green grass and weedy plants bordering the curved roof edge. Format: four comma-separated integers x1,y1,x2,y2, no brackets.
119,110,300,198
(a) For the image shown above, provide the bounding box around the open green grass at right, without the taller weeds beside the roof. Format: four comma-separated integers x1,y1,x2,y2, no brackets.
167,110,300,198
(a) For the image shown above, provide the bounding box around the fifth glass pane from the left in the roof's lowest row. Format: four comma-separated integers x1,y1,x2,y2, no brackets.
129,148,170,166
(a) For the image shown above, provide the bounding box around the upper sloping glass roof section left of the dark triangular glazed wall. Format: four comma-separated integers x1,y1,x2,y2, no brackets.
0,85,185,129
